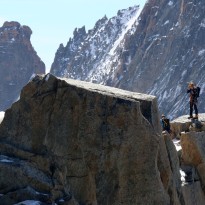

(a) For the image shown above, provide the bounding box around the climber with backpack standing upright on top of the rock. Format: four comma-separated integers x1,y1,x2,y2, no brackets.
187,82,200,119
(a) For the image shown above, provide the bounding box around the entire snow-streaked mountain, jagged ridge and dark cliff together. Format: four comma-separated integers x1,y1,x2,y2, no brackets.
51,0,205,118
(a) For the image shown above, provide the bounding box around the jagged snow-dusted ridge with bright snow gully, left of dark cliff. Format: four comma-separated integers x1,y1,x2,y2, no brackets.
51,6,140,84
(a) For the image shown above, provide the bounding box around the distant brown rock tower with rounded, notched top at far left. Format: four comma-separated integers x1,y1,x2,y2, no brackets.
0,22,45,110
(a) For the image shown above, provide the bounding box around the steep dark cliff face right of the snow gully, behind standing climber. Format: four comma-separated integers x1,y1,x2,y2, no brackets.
119,0,205,117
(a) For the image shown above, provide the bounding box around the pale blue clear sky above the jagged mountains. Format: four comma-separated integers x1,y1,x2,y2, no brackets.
0,0,146,72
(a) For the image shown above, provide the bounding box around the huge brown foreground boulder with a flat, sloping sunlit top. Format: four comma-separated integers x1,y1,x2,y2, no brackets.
0,74,184,205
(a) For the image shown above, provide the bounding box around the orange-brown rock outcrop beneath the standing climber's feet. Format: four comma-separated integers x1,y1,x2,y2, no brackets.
171,114,205,205
